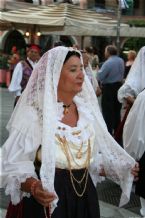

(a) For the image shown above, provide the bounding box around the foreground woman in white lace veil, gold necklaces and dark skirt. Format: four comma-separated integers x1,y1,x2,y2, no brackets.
2,46,138,218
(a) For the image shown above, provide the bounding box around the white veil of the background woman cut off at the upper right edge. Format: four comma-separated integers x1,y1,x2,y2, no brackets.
118,46,145,103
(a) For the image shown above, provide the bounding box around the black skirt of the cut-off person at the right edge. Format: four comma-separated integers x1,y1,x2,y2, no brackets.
135,152,145,199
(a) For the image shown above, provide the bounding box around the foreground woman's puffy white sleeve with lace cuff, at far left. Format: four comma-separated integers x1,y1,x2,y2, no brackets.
2,107,41,204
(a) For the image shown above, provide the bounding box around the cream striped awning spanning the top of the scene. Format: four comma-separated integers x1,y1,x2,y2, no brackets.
0,3,128,36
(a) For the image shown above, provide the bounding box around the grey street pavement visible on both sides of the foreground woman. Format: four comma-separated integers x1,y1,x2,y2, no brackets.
0,88,141,218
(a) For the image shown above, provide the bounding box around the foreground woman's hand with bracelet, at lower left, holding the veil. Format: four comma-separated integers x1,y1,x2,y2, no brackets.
32,181,56,207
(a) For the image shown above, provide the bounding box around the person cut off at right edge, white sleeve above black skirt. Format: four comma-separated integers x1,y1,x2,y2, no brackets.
123,90,145,217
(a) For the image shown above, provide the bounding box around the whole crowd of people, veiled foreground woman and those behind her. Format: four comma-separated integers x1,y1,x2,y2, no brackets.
2,43,145,218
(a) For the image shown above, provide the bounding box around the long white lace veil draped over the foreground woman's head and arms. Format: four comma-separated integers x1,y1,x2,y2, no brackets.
7,46,134,211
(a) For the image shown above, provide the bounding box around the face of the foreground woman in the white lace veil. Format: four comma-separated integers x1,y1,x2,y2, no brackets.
58,55,84,95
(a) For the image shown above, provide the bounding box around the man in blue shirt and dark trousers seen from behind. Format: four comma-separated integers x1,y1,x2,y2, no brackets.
97,45,124,135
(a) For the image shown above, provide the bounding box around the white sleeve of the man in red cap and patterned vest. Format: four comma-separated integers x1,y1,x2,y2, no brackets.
8,62,23,96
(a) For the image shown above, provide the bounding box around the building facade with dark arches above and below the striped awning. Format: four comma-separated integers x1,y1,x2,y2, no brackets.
0,0,145,53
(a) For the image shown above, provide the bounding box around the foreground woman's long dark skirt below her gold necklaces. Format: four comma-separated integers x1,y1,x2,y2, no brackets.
6,169,100,218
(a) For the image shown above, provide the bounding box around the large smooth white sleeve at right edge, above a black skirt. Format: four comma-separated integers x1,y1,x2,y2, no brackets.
123,91,145,160
